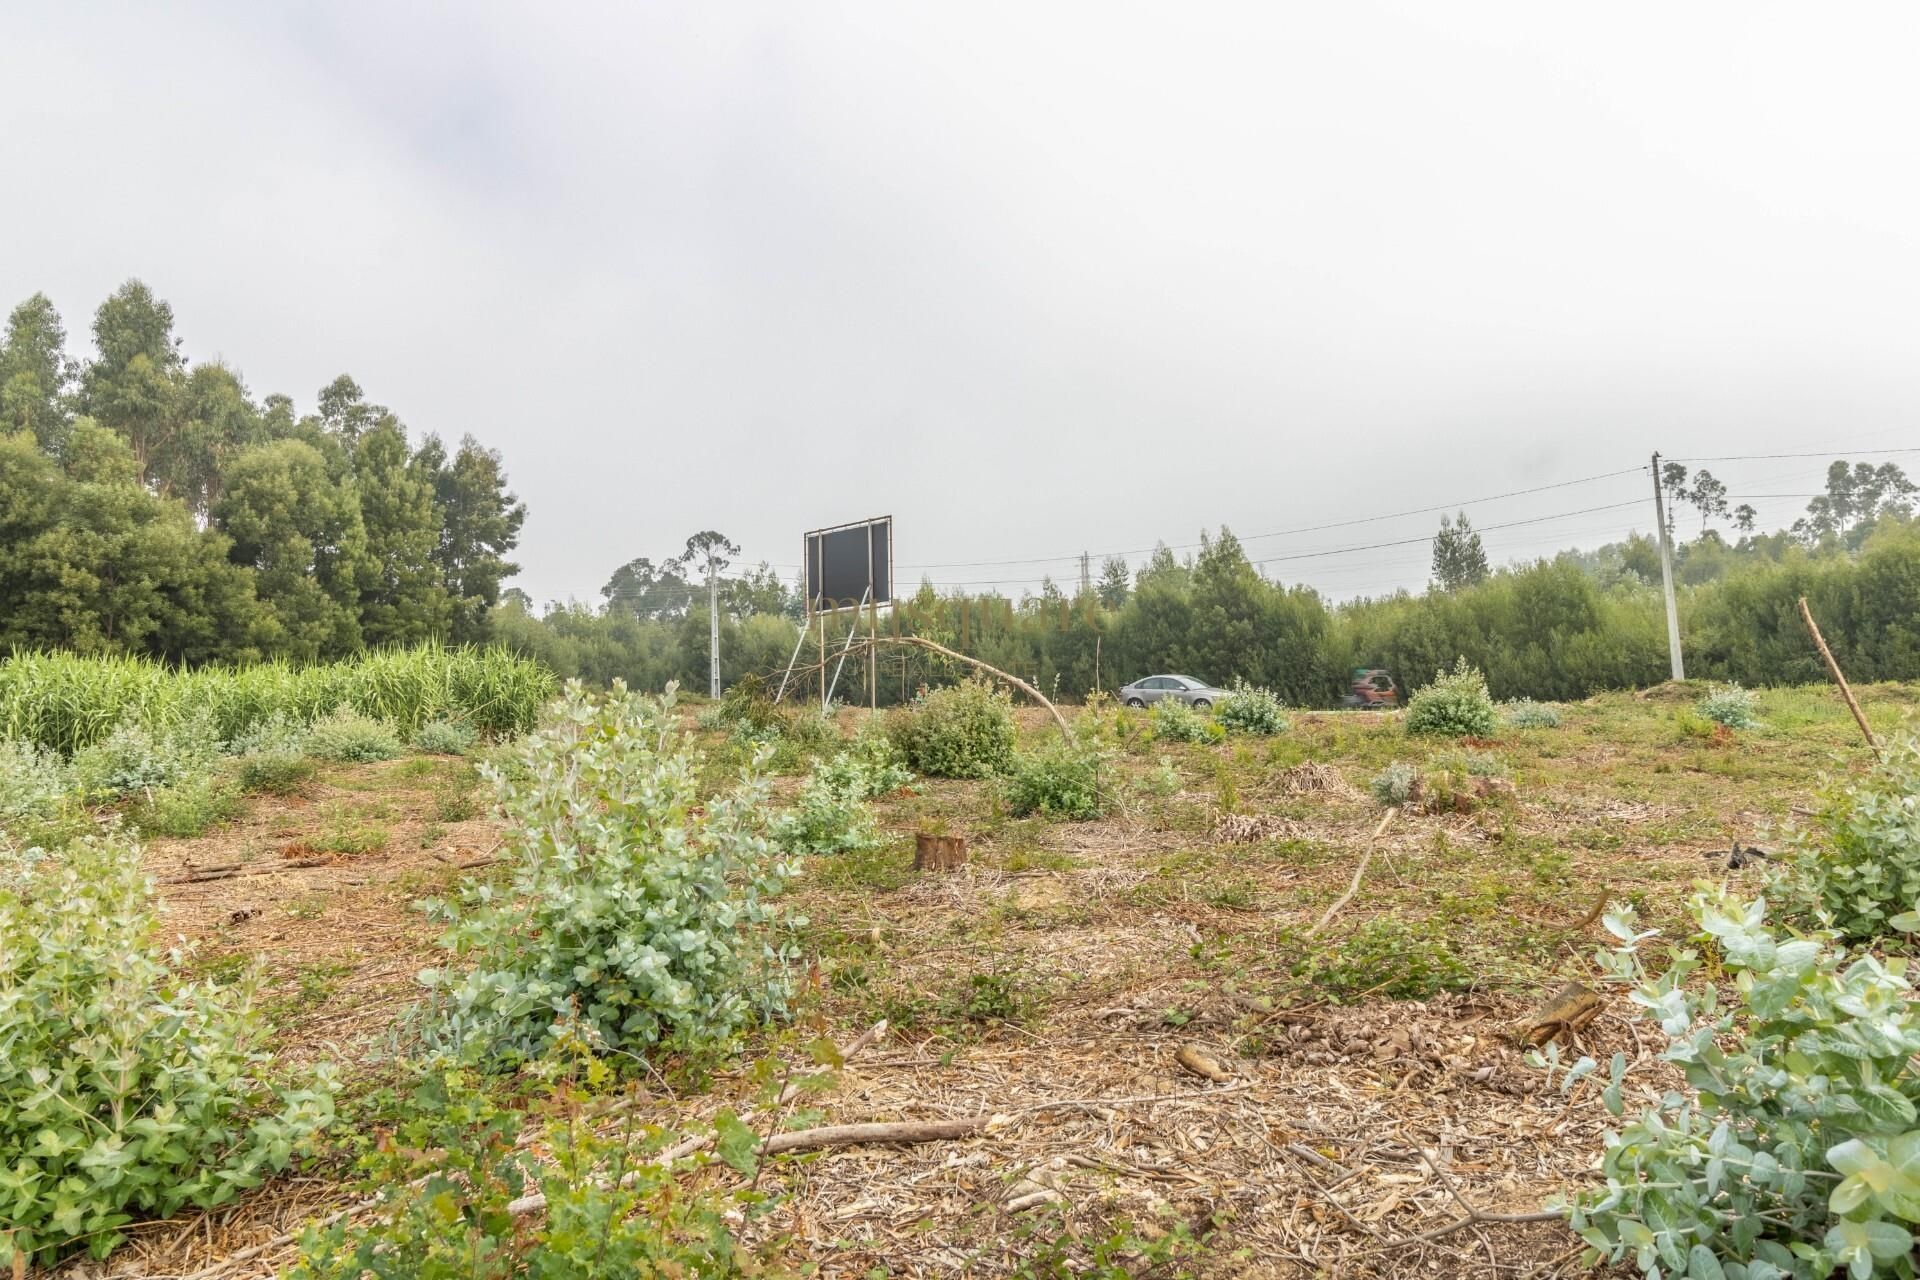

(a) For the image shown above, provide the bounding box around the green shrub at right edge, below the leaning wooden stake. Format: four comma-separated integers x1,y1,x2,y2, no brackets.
1776,737,1920,942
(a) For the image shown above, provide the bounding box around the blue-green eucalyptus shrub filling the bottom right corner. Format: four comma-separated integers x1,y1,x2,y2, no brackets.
1536,889,1920,1280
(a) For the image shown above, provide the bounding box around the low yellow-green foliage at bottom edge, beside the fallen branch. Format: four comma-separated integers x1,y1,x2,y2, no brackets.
288,1073,778,1280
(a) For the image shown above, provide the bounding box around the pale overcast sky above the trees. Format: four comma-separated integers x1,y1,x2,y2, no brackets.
0,0,1920,601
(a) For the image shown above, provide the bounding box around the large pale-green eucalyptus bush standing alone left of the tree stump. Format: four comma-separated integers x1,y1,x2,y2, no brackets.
422,681,795,1065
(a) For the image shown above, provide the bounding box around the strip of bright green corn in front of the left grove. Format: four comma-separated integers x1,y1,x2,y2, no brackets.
0,645,557,756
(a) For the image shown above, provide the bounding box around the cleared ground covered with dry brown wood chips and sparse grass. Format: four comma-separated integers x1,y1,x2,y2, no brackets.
67,687,1914,1280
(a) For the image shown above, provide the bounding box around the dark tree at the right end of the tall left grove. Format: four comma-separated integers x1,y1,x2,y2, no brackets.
420,436,526,643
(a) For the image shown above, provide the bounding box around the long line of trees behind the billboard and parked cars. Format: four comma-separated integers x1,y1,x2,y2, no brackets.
495,461,1920,706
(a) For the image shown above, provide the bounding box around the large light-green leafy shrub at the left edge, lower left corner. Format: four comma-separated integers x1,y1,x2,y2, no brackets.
0,831,332,1261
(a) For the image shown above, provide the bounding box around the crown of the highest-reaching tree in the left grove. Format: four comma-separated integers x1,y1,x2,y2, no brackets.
81,280,186,489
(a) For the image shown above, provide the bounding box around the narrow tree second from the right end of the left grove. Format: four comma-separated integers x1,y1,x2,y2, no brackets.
353,415,445,645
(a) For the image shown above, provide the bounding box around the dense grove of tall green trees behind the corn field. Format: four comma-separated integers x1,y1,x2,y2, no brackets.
0,280,526,662
